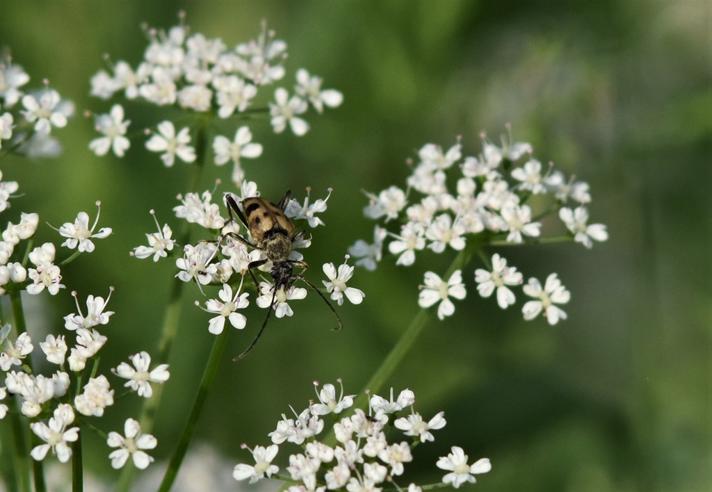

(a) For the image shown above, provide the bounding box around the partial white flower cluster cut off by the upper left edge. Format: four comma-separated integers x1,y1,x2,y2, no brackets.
0,57,74,157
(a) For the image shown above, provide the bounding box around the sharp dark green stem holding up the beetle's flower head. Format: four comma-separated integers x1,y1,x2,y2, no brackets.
158,327,230,492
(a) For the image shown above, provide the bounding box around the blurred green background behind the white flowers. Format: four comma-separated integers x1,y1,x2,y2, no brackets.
0,0,712,492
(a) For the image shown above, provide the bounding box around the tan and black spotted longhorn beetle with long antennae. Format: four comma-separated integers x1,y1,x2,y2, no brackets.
225,191,342,361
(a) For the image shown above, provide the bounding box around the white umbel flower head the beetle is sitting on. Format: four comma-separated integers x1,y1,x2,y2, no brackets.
132,182,365,352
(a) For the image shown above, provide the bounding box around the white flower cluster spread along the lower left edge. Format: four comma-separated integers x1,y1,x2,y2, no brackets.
0,171,169,468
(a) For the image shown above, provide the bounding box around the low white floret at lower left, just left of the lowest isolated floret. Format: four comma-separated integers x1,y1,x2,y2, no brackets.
30,403,79,463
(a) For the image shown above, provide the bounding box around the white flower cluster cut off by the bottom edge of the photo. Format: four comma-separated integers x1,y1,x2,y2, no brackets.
233,381,491,492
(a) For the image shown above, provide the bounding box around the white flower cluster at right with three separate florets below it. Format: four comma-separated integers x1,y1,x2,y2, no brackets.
349,129,608,325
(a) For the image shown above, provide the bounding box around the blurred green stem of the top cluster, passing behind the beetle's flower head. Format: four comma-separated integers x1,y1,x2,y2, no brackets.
116,123,208,492
